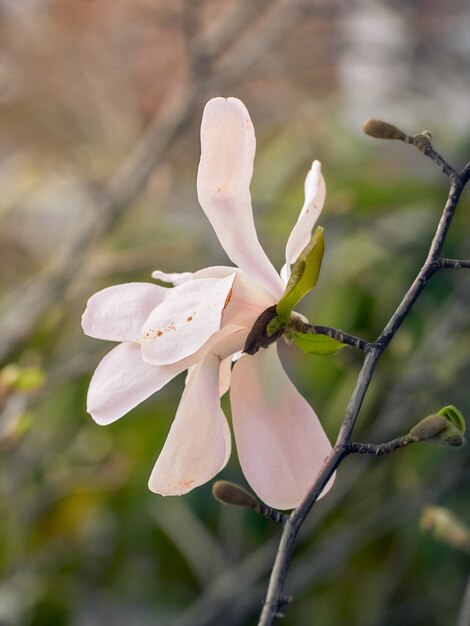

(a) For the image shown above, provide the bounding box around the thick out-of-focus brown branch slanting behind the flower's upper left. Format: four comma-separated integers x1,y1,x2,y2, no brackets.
0,0,299,361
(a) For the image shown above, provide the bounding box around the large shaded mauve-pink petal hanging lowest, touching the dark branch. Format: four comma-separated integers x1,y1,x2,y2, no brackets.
230,346,331,509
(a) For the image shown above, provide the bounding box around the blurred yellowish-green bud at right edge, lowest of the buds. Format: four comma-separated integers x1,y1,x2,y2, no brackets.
420,506,470,554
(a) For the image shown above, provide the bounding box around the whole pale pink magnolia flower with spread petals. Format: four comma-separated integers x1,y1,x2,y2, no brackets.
82,98,331,509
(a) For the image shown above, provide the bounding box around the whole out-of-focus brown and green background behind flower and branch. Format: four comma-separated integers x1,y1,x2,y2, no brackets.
0,0,470,626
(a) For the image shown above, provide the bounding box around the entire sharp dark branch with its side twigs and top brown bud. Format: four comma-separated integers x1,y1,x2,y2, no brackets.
258,120,470,626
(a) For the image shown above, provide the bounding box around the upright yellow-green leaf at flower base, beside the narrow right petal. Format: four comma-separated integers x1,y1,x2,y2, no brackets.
276,226,325,323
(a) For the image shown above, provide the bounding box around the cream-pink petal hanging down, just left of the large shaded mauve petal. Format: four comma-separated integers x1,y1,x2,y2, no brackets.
149,354,230,496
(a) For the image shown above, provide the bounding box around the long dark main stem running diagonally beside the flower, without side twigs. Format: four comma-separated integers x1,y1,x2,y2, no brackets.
258,135,470,626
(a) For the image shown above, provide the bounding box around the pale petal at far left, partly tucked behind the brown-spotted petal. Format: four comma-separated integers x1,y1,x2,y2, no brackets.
82,283,169,341
